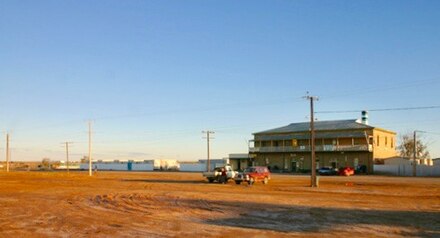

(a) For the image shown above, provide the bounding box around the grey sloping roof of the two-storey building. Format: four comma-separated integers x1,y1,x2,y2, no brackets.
254,119,384,135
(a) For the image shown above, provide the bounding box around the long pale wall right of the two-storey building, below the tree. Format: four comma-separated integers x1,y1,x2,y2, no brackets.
374,164,440,176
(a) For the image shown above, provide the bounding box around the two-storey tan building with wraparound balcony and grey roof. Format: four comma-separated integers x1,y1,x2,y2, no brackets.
249,120,397,173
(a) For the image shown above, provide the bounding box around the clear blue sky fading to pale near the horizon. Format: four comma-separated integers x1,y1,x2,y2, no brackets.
0,0,440,160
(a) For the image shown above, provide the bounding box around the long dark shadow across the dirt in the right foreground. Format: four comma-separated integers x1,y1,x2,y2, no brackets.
201,201,440,237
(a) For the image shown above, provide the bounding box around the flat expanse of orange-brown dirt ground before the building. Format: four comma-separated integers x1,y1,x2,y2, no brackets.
0,171,440,237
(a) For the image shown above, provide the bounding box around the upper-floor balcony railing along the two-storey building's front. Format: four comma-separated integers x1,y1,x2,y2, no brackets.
249,145,373,153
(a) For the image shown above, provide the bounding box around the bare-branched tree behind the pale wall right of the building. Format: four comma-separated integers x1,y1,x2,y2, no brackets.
397,134,430,159
